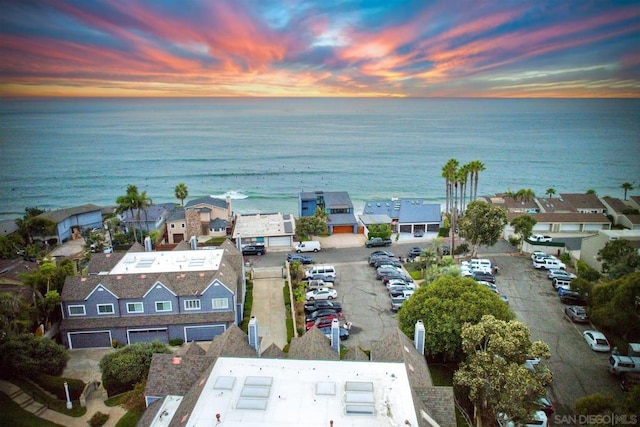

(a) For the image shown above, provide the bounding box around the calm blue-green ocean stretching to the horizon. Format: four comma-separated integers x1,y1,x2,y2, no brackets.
0,98,640,219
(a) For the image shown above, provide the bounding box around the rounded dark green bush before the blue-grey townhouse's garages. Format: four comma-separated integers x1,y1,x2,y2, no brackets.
100,341,170,396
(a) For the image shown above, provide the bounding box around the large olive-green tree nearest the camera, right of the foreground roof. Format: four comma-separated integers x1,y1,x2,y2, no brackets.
453,315,551,425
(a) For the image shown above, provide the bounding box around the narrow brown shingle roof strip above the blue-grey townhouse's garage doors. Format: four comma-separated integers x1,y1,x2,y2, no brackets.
60,311,235,331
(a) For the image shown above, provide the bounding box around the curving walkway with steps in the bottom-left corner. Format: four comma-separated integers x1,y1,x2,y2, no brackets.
0,380,127,427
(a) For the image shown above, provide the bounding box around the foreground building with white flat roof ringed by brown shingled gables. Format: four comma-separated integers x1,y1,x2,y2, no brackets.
138,318,456,427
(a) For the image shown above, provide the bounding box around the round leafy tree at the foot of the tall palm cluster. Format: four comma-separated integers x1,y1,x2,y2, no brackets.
459,200,507,256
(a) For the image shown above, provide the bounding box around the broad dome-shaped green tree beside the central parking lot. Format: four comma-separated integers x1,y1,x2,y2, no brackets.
398,276,513,360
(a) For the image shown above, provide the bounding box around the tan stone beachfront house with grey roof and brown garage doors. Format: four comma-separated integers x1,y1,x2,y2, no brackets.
166,196,233,244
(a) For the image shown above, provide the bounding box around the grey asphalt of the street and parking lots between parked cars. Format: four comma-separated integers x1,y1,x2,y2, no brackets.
246,241,624,424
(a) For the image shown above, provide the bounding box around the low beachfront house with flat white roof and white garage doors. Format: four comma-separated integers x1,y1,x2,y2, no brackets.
233,212,296,249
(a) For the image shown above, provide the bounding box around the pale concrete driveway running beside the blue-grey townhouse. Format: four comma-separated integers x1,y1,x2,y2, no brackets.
251,267,287,351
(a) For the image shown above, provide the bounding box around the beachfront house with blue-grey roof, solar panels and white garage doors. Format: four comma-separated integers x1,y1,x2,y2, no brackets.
360,198,442,234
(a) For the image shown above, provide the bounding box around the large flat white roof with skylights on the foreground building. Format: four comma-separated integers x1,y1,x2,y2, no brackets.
181,357,418,427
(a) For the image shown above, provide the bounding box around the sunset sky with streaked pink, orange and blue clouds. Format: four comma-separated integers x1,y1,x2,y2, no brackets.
0,0,640,98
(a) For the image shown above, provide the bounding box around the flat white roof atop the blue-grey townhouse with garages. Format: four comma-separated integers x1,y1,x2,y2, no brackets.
109,249,224,275
